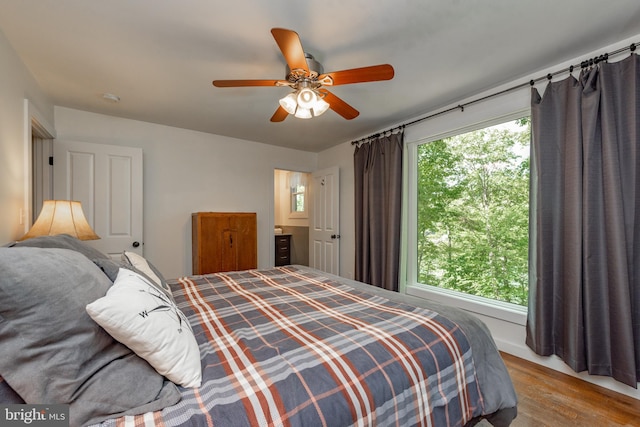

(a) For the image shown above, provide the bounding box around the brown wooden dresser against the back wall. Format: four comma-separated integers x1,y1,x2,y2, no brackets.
191,212,258,274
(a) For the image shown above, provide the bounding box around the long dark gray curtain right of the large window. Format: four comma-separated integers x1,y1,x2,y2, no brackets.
527,55,640,387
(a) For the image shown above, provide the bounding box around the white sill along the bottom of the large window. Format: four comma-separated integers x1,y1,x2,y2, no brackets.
405,285,527,326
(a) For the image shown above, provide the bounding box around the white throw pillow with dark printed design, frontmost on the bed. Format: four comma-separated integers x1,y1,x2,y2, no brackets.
86,268,202,387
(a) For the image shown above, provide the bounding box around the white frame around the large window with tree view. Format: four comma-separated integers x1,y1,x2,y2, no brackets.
401,106,531,325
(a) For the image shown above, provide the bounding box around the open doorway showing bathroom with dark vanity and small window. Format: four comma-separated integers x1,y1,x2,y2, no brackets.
273,169,311,266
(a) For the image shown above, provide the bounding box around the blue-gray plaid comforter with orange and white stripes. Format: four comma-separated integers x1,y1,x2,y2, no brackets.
105,267,483,427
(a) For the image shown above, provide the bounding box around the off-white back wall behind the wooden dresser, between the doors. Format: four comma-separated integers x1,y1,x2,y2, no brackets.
54,107,317,278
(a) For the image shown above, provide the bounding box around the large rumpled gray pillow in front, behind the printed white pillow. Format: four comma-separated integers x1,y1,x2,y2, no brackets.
0,247,180,425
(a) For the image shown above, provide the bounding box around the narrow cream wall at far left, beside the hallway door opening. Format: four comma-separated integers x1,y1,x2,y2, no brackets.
0,32,53,245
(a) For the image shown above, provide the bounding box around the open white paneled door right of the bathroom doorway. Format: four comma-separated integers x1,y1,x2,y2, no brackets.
309,167,340,275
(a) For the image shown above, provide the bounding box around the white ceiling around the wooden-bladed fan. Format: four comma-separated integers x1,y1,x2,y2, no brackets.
0,0,640,152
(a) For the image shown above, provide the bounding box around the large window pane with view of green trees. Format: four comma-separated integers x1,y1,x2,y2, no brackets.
415,117,530,305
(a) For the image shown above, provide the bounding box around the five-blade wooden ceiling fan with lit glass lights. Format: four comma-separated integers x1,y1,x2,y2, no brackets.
213,28,394,122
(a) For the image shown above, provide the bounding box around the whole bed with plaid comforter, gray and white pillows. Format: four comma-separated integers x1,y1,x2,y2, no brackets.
0,236,517,427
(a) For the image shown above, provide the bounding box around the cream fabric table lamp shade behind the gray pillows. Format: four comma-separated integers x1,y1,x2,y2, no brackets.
20,200,100,240
